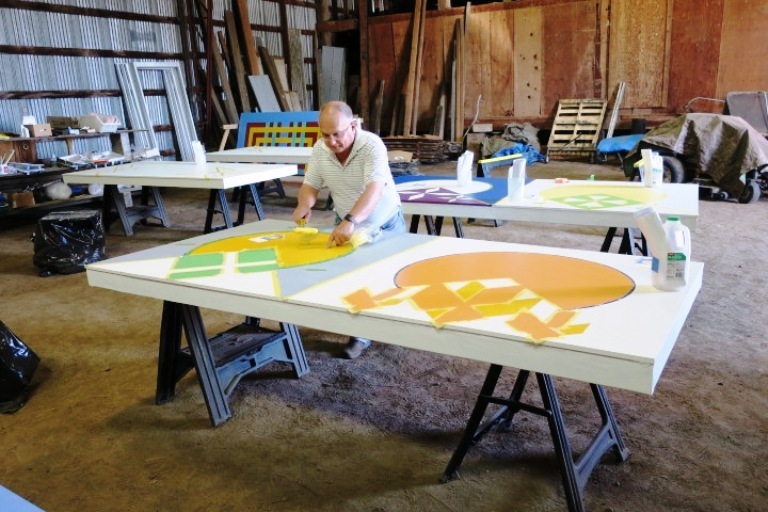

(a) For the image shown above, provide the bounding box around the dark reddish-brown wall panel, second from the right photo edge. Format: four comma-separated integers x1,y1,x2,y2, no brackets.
667,0,727,112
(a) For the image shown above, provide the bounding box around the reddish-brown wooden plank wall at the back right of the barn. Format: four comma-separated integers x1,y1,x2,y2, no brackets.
368,0,768,132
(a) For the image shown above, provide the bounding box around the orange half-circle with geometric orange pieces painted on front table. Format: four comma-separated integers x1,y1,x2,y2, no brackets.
343,252,635,343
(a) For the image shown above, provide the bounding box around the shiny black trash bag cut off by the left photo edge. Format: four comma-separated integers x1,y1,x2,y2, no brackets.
0,321,40,414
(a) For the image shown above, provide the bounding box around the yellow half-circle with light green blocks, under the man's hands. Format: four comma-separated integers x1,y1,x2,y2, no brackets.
168,231,354,279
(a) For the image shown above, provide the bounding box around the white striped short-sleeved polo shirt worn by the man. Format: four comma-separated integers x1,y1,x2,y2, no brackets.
304,129,400,227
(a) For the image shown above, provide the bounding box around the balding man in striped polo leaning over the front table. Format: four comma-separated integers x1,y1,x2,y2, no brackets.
293,101,405,359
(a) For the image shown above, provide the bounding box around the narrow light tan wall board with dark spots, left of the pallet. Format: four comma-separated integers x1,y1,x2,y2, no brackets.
514,7,542,117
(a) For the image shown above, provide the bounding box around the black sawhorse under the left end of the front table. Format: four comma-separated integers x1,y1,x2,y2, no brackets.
155,301,309,427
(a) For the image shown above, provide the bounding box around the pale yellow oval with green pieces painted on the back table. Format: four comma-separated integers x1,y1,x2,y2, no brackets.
540,185,667,210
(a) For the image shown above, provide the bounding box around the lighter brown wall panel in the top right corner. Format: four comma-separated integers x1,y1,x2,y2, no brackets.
717,0,768,98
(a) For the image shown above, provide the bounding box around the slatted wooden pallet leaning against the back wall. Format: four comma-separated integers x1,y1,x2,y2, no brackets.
547,99,607,158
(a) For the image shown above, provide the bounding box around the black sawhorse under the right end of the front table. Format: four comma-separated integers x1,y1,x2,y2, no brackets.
441,365,629,512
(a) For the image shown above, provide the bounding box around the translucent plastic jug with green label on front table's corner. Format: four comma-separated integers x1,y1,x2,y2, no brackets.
651,217,691,290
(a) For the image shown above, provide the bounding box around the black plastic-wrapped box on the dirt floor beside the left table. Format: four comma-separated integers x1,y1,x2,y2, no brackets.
32,210,107,276
